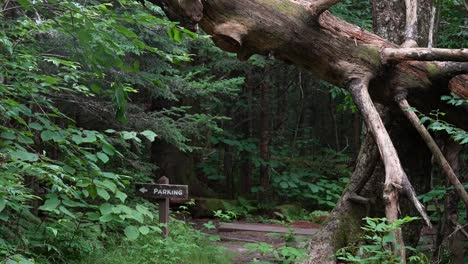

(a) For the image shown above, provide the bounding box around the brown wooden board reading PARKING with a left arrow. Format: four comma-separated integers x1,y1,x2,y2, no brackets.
136,183,188,200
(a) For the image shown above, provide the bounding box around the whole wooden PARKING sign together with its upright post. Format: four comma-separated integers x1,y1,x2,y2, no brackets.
135,176,188,236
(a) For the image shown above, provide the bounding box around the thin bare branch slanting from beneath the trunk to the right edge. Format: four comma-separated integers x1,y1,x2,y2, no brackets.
396,96,468,208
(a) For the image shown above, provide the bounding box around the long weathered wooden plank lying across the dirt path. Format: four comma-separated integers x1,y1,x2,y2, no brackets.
218,223,317,236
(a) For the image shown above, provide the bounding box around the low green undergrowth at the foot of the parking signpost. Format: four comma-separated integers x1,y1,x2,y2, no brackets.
69,220,232,264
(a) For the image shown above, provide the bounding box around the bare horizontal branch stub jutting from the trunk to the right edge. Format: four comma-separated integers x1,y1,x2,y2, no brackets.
381,48,468,62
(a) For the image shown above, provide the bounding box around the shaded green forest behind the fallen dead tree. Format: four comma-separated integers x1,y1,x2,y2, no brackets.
0,0,468,263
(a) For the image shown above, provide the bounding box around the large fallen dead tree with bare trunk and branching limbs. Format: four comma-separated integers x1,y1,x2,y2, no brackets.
152,0,468,263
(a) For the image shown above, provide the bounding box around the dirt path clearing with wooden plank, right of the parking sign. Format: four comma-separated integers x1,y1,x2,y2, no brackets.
192,219,320,264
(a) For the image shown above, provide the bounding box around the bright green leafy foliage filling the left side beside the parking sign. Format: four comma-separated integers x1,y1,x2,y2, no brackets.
0,1,239,263
